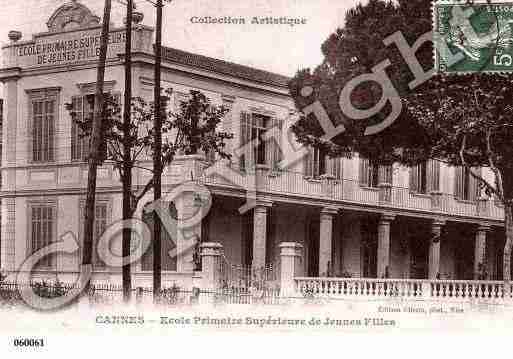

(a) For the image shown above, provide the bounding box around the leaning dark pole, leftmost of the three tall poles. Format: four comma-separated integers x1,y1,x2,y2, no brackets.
81,0,111,292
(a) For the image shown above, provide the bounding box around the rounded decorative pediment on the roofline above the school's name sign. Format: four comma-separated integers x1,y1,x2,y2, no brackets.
46,0,100,32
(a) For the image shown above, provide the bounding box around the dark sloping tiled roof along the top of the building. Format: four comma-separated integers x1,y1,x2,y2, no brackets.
162,47,290,87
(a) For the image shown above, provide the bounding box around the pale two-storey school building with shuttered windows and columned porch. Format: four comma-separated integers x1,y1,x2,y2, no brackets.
0,2,504,290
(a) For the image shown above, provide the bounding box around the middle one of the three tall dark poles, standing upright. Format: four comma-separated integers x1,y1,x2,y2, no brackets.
122,0,133,303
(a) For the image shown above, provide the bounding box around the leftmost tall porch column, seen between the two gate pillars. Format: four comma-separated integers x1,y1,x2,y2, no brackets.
251,201,272,269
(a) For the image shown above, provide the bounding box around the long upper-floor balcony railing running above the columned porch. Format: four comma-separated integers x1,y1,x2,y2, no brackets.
197,164,504,220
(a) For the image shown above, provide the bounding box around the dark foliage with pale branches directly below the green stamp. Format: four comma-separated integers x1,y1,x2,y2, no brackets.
405,74,513,204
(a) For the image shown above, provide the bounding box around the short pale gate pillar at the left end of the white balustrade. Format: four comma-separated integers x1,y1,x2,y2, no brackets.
280,242,303,297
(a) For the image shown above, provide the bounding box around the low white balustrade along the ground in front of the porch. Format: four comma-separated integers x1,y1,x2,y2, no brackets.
295,278,513,301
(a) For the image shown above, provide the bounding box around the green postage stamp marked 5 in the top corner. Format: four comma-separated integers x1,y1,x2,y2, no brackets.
433,0,513,73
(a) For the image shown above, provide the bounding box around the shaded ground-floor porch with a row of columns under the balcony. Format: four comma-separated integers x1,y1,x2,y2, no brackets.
201,195,504,280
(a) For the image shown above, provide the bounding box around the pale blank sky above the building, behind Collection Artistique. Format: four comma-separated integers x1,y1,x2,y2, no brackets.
0,0,358,94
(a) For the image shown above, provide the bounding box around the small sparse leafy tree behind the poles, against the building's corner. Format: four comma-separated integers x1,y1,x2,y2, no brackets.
66,89,233,290
